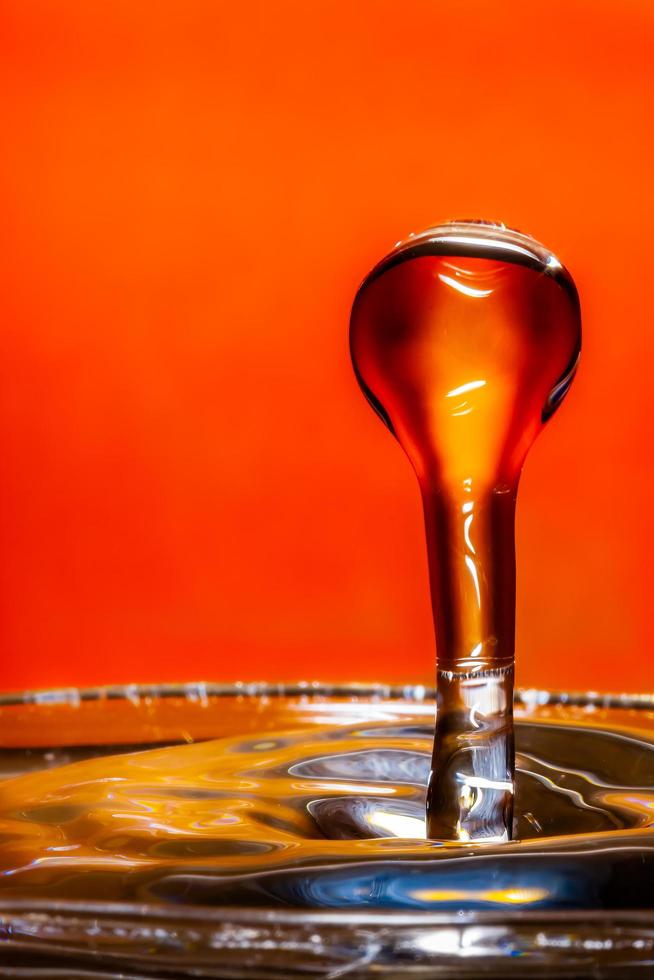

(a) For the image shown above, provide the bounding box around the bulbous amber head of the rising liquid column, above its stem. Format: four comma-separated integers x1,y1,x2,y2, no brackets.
350,221,581,487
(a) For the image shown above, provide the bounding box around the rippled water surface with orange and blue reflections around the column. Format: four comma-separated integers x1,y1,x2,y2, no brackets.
0,717,654,910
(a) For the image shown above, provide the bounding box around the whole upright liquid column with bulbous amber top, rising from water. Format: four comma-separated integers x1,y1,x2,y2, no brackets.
350,222,580,840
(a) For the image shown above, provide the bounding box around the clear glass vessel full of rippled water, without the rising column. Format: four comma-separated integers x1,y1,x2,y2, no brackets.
0,690,654,980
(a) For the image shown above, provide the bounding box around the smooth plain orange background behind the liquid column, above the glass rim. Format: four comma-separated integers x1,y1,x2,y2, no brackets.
0,0,654,690
